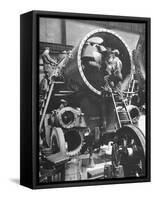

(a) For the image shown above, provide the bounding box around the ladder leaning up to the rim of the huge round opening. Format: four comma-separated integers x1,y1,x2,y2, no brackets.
111,91,132,128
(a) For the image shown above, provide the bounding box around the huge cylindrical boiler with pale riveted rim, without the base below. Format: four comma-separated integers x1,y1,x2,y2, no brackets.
62,29,132,95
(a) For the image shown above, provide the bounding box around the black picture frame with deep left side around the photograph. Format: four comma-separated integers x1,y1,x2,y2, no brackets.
20,11,151,189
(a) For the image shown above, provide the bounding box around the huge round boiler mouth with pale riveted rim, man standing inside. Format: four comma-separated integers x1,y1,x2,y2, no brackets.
78,29,131,95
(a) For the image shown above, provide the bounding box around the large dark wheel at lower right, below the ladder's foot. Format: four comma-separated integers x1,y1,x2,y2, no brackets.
112,125,145,177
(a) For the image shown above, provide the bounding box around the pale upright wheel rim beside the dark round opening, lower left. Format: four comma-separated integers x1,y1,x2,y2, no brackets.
49,127,66,154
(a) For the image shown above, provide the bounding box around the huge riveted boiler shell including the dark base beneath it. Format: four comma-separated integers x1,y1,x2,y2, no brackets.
58,28,136,131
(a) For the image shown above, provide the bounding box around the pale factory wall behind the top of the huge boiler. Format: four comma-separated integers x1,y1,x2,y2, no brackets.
40,18,144,51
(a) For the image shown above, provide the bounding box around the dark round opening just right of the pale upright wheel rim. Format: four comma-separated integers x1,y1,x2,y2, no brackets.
65,130,82,154
